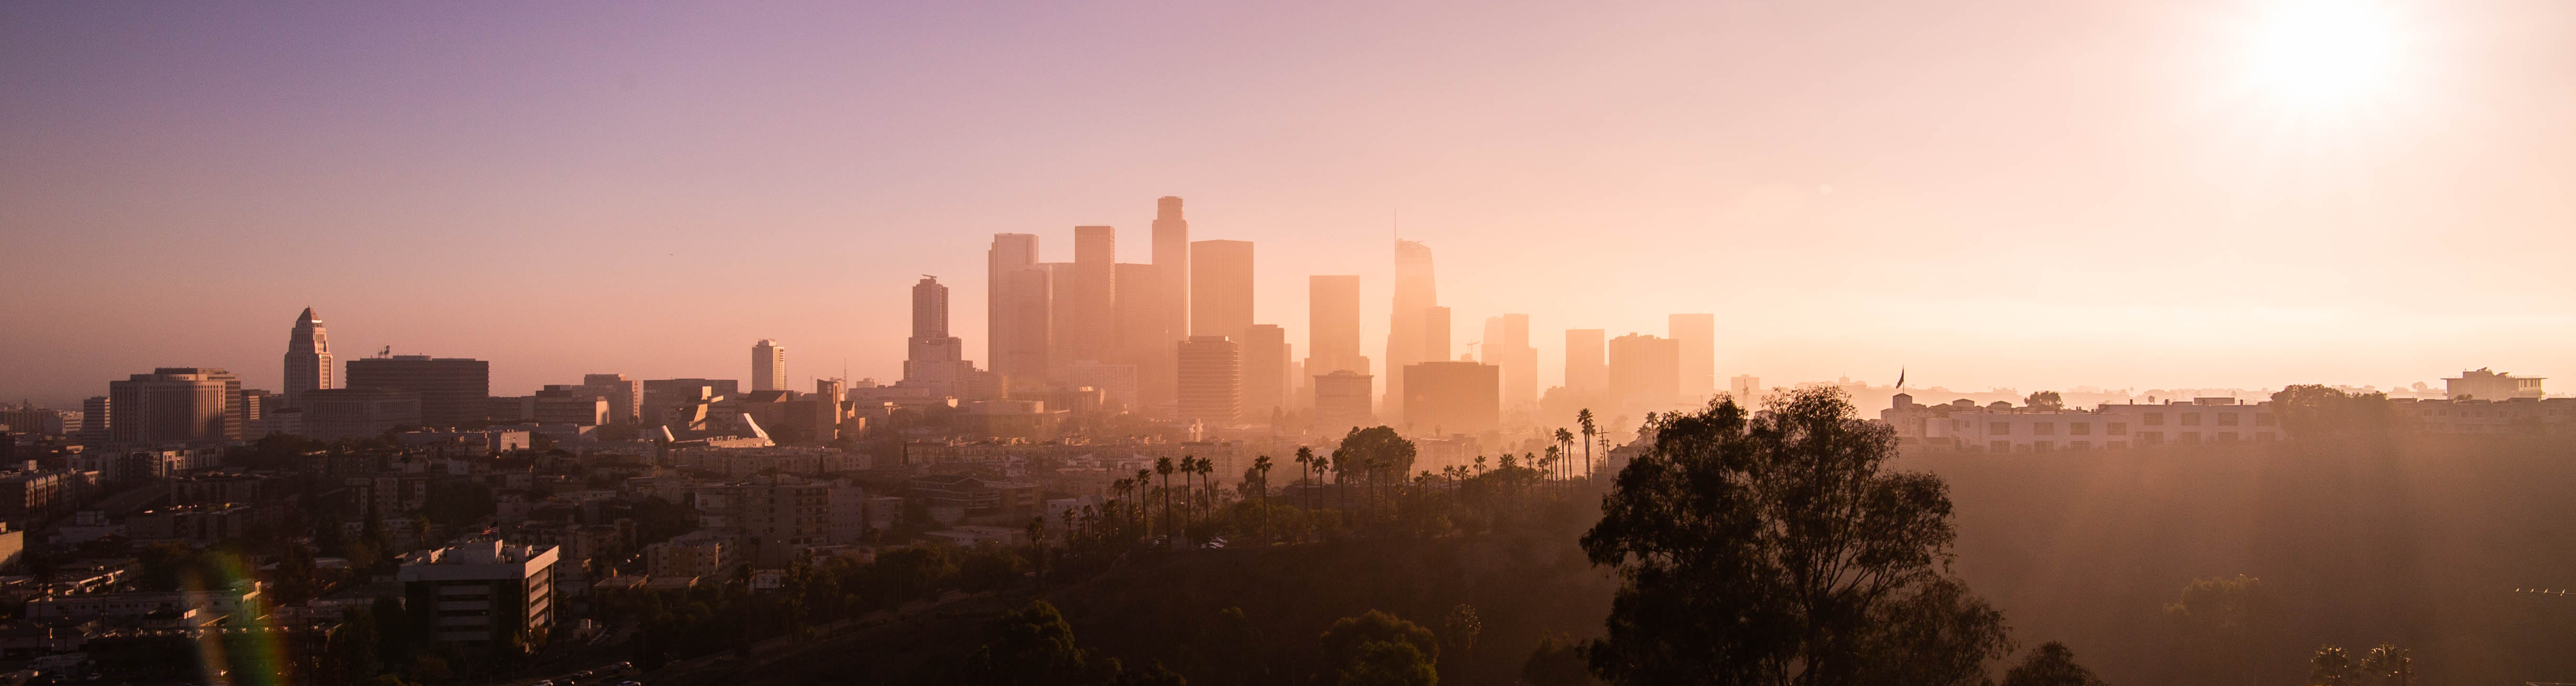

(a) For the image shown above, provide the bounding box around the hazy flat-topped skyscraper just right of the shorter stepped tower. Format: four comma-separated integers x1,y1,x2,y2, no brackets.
984,234,1054,387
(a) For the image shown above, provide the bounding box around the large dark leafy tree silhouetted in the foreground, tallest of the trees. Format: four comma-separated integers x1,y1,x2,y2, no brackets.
1582,387,2009,686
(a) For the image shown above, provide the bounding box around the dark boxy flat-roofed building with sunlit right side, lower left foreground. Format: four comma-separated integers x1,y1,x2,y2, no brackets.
394,539,557,647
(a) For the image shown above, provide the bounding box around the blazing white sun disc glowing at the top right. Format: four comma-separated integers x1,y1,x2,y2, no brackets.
2249,0,2401,108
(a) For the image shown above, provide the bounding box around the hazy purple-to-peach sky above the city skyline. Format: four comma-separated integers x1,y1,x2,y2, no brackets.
0,0,2576,402
